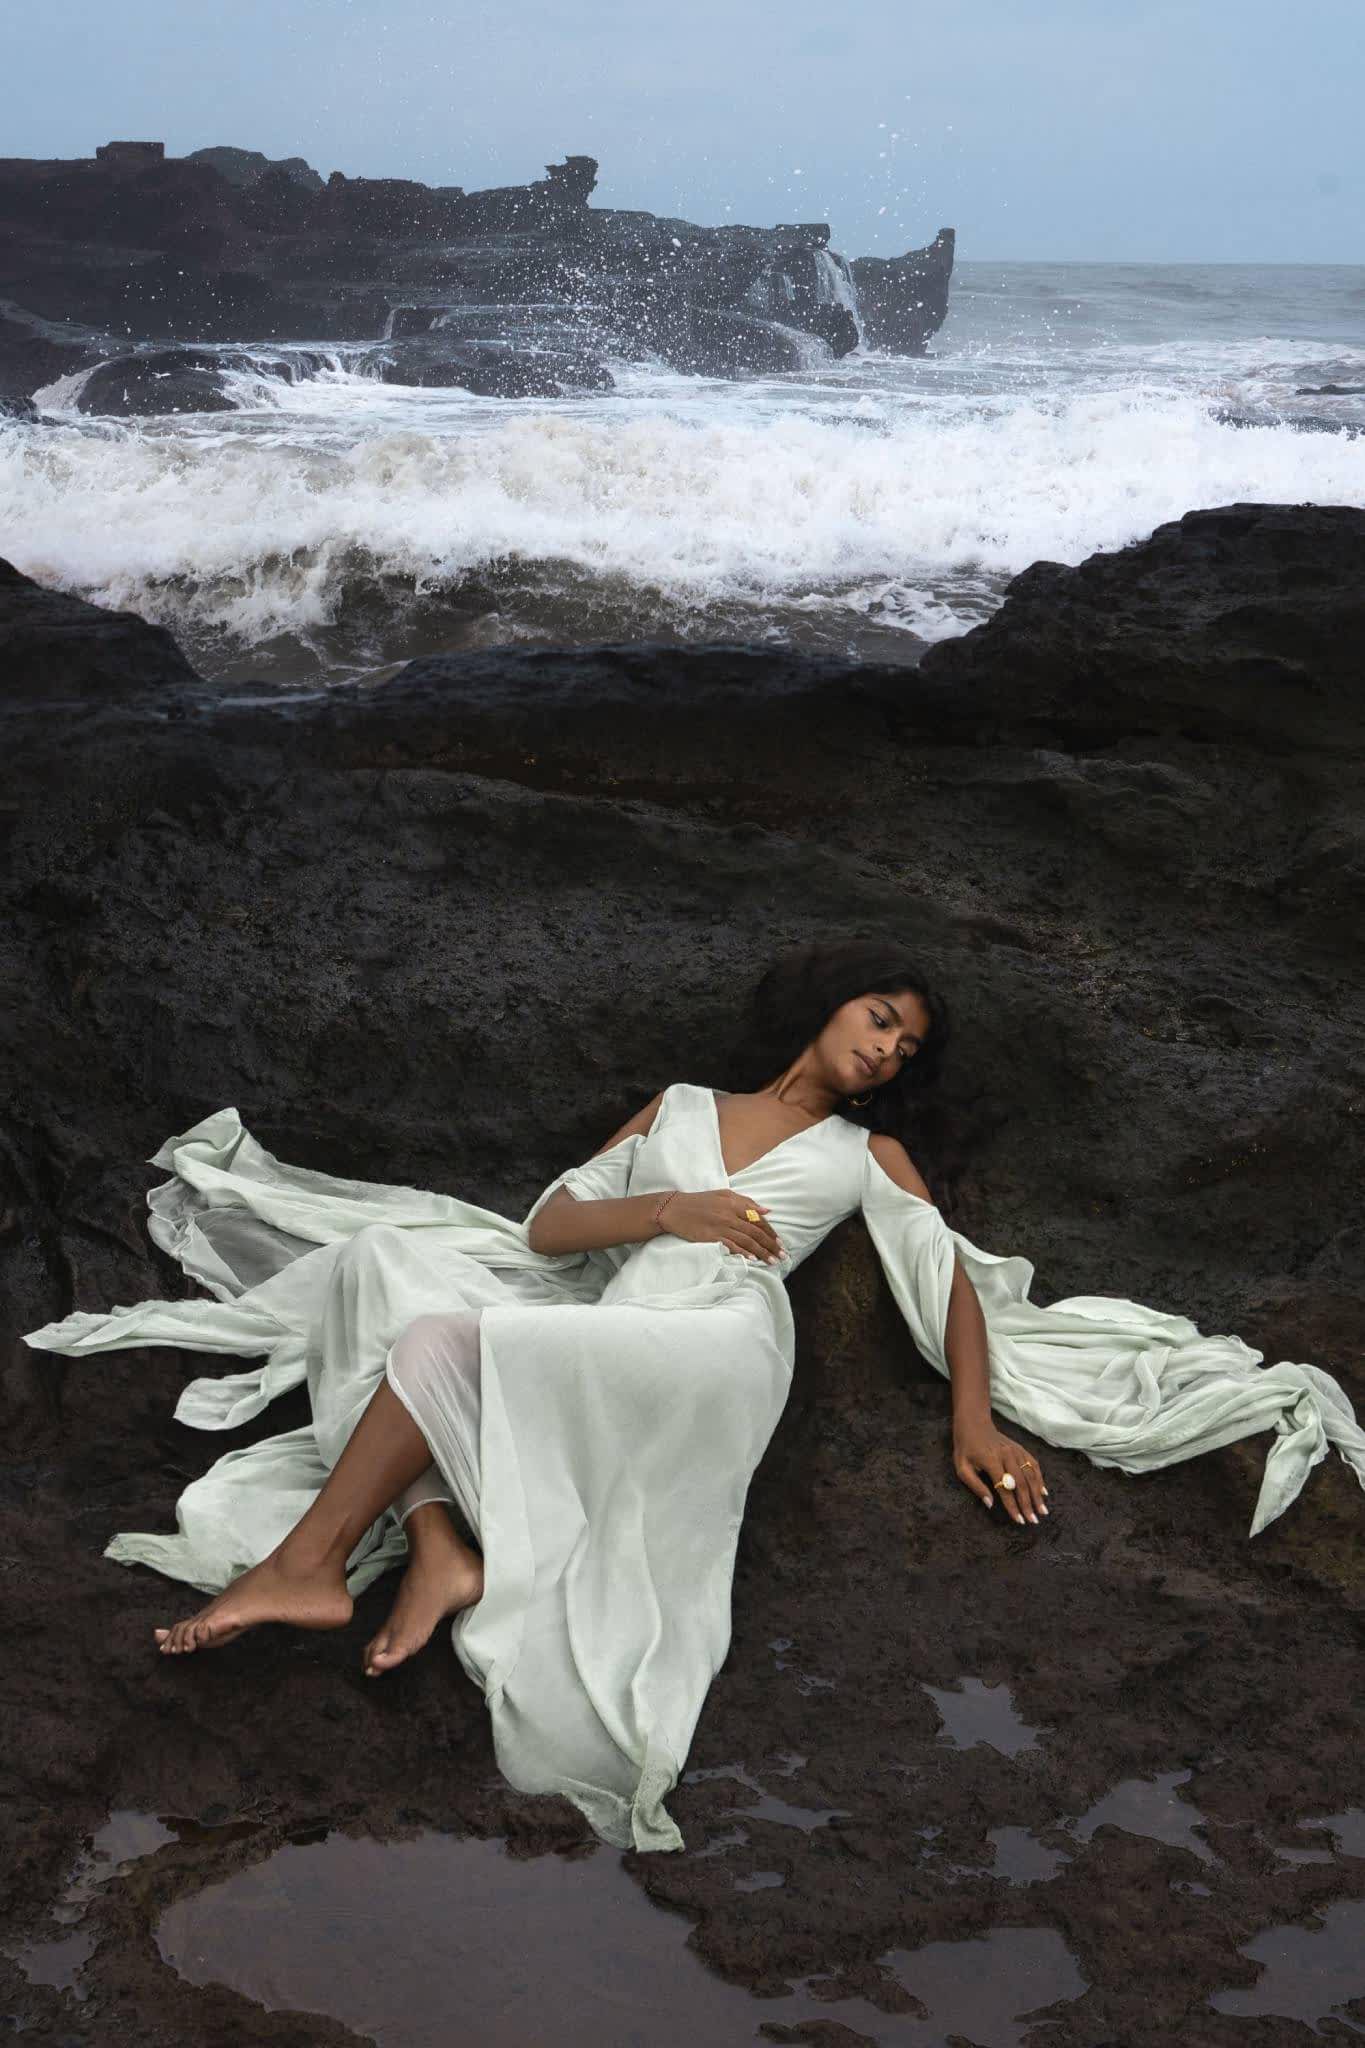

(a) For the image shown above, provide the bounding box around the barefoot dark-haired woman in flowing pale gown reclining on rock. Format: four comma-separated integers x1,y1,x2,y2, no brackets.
27,940,1365,1849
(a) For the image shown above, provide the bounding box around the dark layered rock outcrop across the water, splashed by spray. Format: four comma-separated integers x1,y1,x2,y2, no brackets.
0,143,952,412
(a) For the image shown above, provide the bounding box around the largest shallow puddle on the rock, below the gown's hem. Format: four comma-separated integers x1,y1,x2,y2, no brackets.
158,1833,1087,2048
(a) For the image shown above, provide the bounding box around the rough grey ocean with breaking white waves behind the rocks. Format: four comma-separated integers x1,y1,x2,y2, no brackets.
0,262,1365,682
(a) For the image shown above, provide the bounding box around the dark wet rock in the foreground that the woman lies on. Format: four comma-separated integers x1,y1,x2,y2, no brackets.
0,508,1365,2048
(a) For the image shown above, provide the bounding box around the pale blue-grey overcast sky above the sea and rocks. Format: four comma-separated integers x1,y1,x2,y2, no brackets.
0,0,1365,262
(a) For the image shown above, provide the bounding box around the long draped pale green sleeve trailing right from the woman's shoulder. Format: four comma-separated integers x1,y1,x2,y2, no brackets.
862,1151,1365,1536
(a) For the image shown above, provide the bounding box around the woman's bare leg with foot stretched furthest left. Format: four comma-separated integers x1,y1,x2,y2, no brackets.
156,1380,444,1657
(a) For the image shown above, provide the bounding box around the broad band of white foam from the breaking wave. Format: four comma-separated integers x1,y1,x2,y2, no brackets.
0,373,1365,643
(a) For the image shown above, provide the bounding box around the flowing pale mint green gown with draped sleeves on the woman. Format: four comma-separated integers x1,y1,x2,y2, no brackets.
27,1081,1365,1849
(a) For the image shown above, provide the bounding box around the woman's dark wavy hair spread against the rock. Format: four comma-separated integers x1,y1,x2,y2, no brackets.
731,936,950,1151
